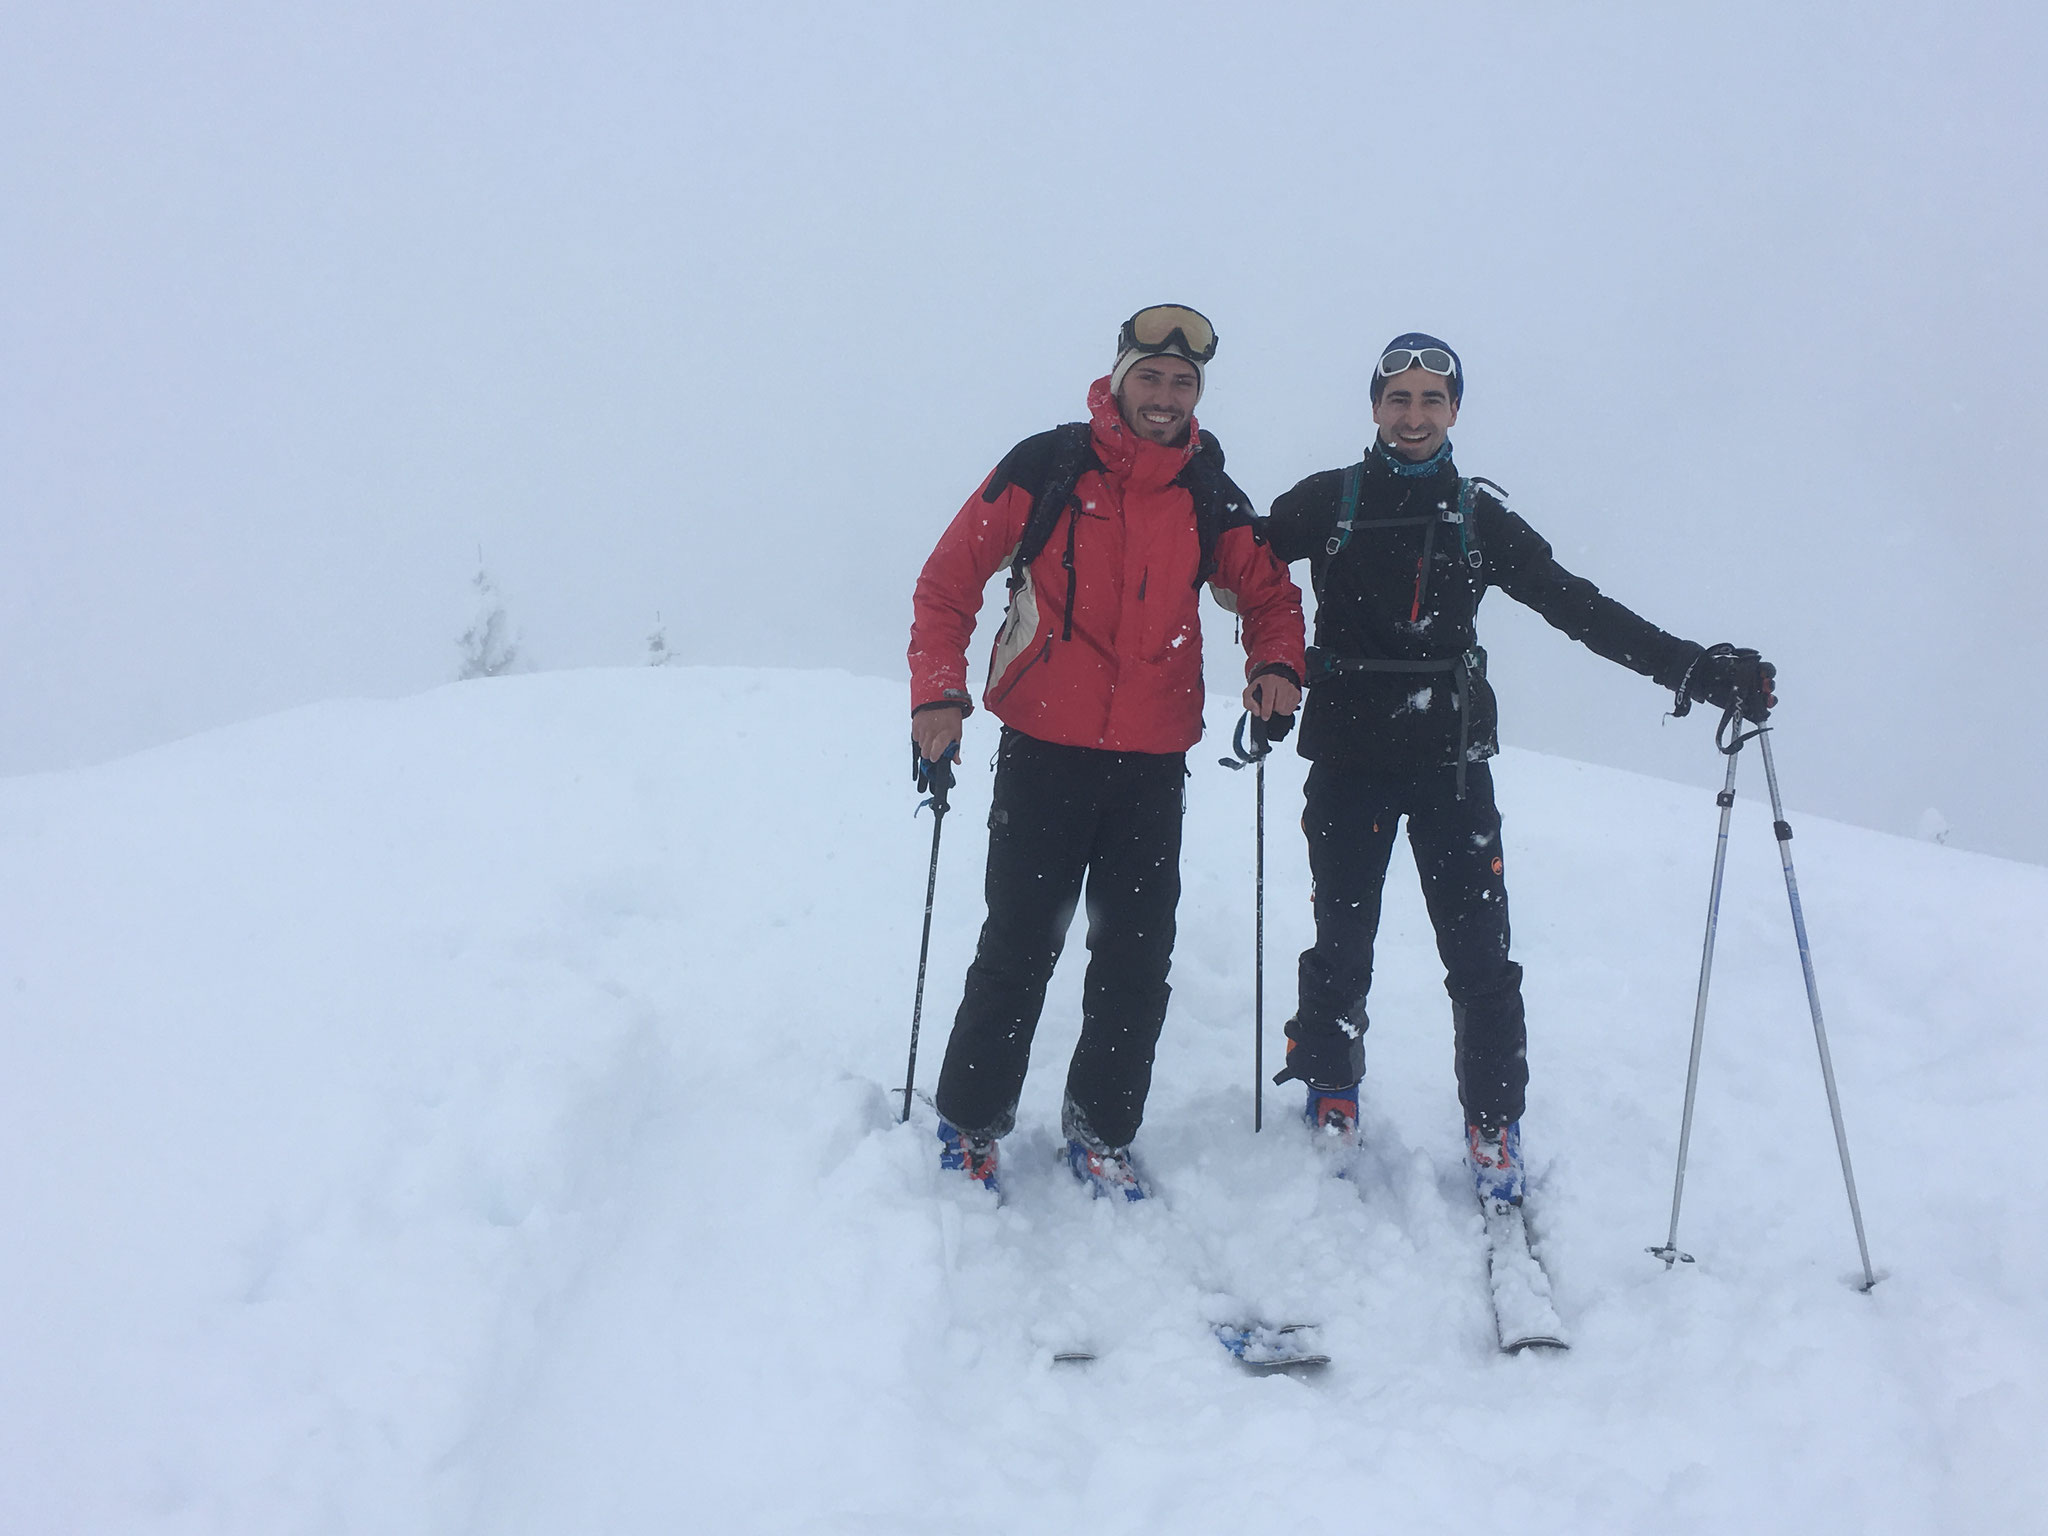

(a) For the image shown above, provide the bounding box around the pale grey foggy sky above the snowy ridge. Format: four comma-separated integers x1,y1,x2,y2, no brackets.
0,0,2048,860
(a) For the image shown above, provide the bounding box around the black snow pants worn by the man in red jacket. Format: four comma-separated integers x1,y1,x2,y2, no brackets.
938,727,1188,1149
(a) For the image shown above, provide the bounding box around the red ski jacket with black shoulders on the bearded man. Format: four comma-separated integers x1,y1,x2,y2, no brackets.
909,377,1305,752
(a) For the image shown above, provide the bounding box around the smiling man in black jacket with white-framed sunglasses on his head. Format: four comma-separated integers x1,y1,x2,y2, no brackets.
1266,332,1778,1204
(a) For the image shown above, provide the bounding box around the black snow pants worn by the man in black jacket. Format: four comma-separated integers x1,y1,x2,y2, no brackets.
1286,762,1530,1126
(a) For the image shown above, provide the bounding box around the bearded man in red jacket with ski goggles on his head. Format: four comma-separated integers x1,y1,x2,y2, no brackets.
909,305,1303,1200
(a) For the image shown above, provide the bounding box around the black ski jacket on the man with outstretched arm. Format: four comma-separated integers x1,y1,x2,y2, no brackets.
1262,453,1702,776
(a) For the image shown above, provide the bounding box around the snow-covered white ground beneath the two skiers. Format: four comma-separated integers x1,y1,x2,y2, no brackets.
0,670,2048,1536
